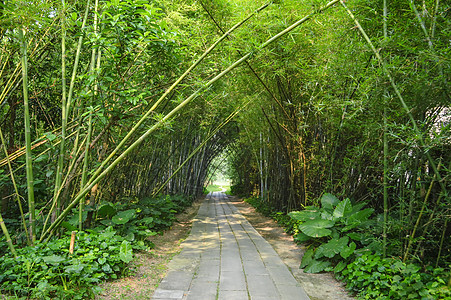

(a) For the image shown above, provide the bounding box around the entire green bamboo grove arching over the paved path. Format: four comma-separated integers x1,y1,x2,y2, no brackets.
0,0,451,286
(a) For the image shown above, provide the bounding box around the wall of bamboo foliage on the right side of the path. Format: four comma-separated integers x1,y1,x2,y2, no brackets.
224,1,451,270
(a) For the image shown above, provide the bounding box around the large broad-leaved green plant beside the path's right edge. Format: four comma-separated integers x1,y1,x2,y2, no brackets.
288,193,380,273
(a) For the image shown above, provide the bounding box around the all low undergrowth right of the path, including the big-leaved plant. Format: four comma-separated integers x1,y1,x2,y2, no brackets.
245,193,451,299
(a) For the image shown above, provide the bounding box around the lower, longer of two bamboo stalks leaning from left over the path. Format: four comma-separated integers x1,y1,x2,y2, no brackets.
40,0,340,241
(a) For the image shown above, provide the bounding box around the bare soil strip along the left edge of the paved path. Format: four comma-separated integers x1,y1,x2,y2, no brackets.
96,198,203,300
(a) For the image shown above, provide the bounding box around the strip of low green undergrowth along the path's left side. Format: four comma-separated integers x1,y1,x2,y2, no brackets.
0,195,192,299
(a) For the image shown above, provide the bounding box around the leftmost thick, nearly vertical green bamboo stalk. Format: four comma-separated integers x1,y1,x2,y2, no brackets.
19,29,36,244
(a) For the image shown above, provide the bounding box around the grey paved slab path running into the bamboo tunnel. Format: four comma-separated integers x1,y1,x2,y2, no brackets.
152,192,309,300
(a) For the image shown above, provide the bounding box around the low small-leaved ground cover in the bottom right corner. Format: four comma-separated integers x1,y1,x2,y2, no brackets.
336,253,451,299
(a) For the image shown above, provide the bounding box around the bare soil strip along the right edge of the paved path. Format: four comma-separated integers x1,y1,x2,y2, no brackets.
229,196,354,300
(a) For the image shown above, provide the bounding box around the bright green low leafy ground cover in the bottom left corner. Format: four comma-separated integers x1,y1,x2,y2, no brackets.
0,227,133,299
